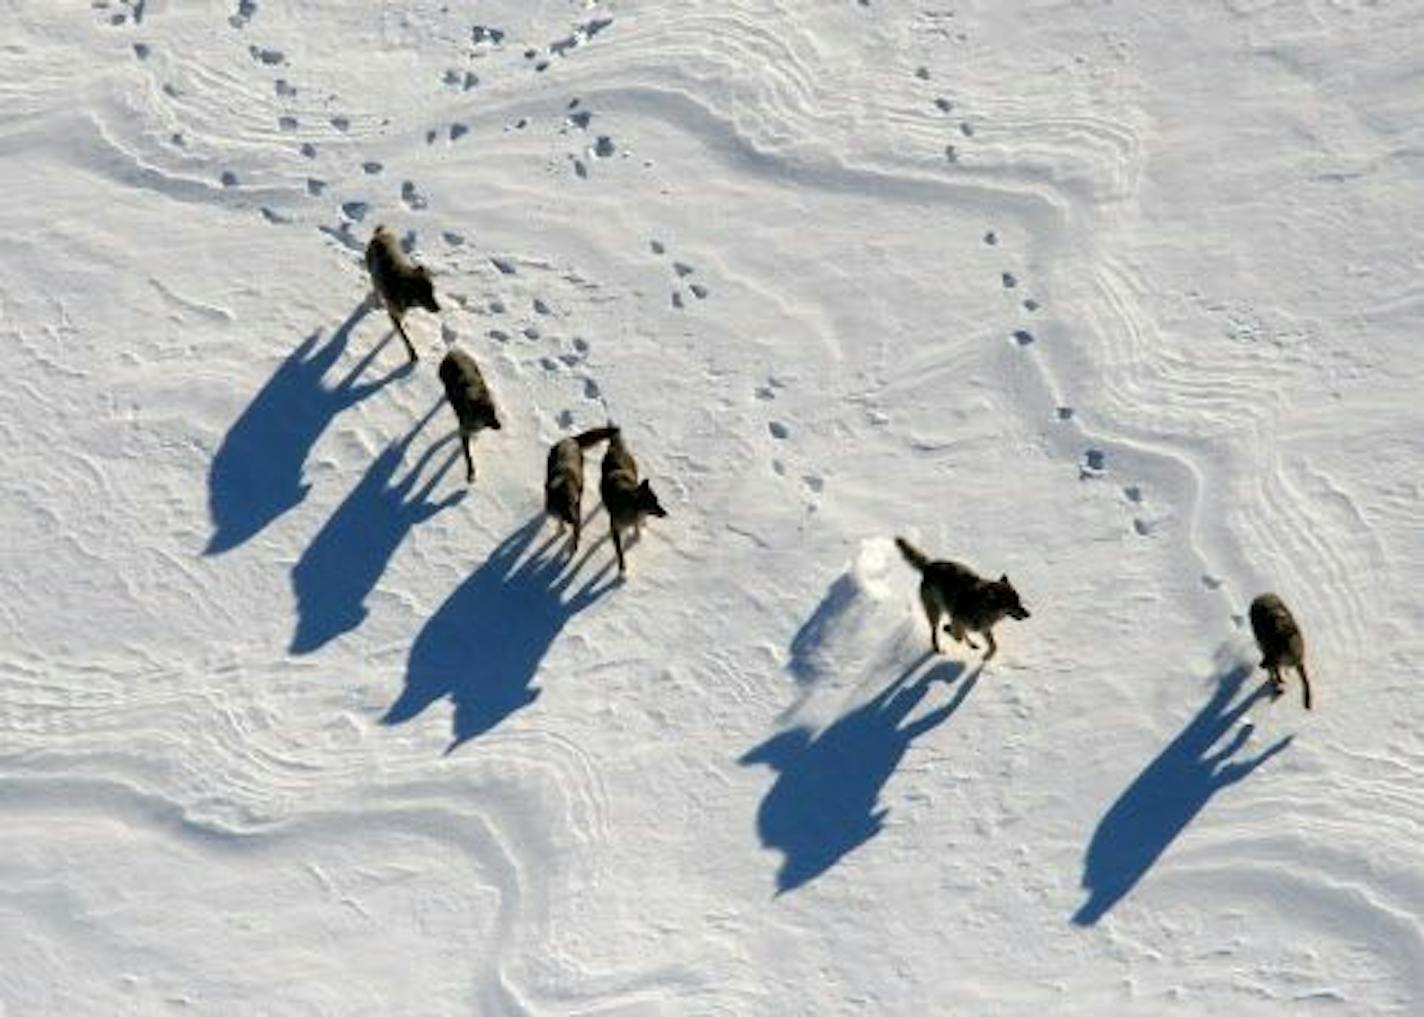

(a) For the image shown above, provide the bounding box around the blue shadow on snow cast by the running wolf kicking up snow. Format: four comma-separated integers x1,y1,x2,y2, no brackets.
739,652,978,896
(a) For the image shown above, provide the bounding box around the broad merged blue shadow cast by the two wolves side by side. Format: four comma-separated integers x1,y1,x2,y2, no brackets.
382,514,618,752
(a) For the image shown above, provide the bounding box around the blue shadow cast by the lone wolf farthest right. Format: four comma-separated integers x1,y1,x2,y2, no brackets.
1072,667,1290,926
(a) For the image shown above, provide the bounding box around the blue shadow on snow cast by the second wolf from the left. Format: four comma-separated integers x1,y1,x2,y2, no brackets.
290,400,464,654
